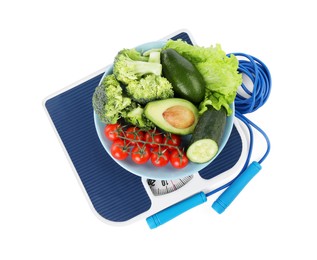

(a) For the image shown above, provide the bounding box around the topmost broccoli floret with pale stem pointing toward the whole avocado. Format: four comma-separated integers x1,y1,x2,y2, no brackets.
113,49,162,84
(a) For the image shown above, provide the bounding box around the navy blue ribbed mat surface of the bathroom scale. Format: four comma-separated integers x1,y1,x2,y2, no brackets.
45,33,242,222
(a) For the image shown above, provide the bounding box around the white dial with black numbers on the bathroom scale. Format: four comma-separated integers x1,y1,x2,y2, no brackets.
147,175,193,196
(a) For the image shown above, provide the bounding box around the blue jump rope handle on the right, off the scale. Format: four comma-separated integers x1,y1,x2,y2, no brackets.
212,162,262,214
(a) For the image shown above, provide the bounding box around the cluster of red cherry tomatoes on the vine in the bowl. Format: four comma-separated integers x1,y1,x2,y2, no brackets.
104,124,188,169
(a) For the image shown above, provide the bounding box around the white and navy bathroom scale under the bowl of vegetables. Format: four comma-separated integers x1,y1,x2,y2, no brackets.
43,31,253,228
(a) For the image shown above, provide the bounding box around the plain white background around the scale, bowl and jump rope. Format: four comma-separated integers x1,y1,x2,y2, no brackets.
0,0,317,259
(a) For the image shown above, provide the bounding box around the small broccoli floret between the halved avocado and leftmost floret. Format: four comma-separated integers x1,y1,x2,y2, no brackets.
124,102,155,129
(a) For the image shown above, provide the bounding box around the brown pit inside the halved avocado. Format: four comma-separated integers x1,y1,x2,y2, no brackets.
162,105,195,129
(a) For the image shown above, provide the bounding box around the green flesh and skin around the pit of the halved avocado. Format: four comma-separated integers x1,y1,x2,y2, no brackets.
144,98,199,135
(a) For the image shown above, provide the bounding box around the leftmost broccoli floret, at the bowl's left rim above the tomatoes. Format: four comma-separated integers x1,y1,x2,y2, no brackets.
92,74,132,124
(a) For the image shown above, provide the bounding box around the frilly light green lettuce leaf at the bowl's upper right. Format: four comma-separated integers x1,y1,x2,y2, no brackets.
164,40,242,116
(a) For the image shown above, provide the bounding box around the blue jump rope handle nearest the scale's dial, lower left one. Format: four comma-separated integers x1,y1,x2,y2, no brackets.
146,192,207,229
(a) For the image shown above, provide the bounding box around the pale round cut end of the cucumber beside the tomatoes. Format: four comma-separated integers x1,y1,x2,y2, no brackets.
187,139,218,163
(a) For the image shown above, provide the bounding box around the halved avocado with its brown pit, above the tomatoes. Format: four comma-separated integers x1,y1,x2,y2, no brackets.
144,98,198,135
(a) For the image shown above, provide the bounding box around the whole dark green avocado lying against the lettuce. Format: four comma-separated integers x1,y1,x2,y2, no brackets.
161,49,206,104
